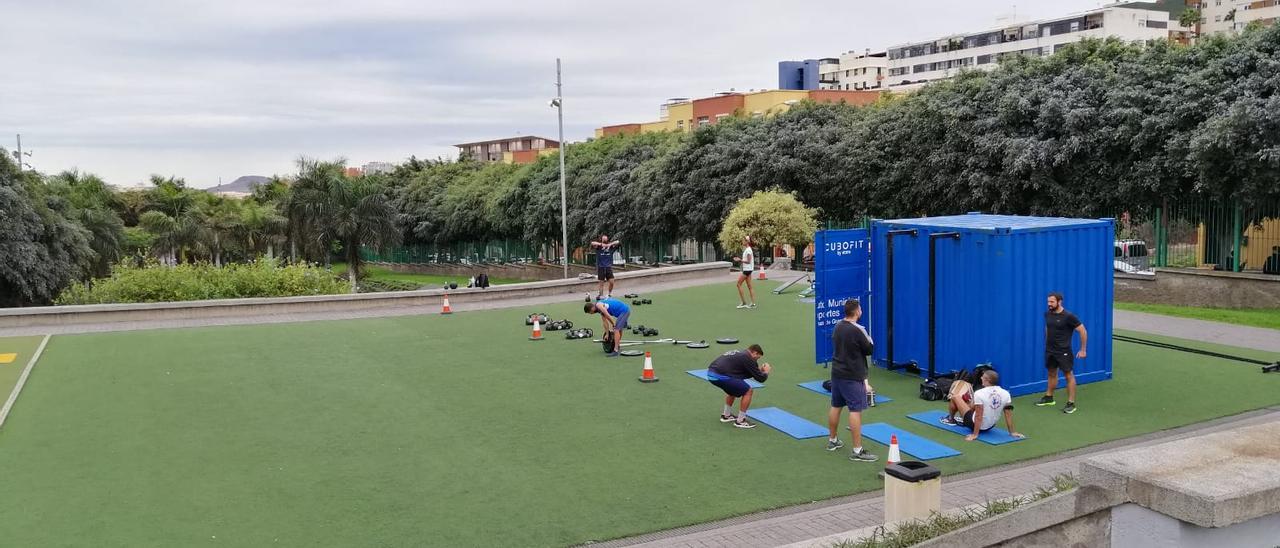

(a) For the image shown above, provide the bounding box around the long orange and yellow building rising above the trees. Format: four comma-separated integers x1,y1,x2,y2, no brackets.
595,90,881,137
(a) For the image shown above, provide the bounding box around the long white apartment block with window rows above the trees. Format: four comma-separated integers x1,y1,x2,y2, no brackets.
778,0,1182,91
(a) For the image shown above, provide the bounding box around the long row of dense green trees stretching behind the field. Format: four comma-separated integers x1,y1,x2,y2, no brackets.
0,27,1280,305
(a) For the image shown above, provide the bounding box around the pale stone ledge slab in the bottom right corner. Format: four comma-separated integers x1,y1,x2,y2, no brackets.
1080,421,1280,528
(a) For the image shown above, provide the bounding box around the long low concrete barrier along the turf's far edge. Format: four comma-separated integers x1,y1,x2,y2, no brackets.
0,262,730,330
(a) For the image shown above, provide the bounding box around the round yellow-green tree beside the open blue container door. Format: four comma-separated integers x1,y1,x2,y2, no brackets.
718,191,818,250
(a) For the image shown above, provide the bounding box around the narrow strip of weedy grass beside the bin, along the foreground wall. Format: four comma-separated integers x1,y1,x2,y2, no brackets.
832,475,1078,548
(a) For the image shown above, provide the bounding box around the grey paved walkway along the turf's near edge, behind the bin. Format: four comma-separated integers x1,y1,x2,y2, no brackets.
593,407,1280,548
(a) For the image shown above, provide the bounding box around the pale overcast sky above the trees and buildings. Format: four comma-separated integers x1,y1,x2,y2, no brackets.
0,0,1100,187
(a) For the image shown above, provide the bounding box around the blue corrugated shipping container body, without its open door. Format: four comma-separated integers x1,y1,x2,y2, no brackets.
869,214,1115,396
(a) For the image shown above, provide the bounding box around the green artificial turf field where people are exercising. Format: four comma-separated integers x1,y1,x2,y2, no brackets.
0,282,1280,547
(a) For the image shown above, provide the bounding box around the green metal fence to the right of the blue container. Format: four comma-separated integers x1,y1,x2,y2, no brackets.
1116,198,1280,274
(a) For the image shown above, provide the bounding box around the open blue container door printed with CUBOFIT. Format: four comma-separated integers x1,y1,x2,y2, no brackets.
813,228,870,364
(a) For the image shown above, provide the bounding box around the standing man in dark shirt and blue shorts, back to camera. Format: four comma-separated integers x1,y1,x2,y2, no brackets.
827,298,877,462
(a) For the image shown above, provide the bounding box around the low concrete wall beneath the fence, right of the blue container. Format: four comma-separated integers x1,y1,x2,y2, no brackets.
1115,269,1280,309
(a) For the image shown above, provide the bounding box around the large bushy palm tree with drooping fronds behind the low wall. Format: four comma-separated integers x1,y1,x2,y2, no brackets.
289,157,401,292
